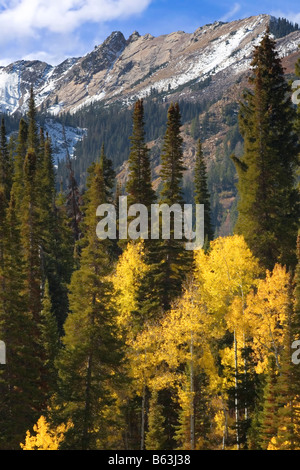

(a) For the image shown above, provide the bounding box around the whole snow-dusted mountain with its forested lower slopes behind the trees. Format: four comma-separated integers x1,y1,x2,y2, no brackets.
0,14,300,235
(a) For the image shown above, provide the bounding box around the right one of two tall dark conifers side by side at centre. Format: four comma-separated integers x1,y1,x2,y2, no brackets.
148,103,191,315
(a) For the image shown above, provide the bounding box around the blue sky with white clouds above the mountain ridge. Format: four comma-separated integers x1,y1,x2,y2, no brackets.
0,0,300,65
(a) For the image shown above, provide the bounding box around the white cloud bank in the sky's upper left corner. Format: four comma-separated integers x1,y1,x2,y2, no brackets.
0,0,152,42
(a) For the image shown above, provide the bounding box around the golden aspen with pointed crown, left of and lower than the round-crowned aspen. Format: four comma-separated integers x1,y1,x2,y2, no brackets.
155,280,219,449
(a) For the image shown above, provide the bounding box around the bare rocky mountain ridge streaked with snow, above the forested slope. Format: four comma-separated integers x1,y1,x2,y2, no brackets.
0,15,300,115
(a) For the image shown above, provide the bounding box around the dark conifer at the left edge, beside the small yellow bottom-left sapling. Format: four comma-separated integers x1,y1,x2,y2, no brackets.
0,188,43,450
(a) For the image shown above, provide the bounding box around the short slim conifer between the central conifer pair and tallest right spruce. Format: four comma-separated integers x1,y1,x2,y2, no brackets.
194,139,214,246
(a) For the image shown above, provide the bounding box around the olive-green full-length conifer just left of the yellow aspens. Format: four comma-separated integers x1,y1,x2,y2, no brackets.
58,157,119,450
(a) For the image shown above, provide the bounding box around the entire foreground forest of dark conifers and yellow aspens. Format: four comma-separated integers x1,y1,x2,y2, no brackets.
0,31,300,450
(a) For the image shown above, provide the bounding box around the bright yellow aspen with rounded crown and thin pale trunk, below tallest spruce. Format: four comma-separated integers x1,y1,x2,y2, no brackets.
195,235,260,449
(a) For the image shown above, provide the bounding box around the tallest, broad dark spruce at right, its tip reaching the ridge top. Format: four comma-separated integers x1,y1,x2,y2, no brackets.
232,30,299,269
